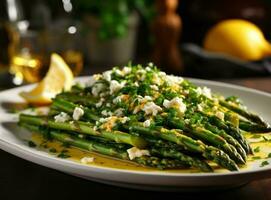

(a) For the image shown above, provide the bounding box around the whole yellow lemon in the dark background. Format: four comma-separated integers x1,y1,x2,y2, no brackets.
203,19,271,61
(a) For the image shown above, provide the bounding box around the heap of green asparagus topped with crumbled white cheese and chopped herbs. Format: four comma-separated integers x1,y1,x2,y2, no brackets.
19,63,271,172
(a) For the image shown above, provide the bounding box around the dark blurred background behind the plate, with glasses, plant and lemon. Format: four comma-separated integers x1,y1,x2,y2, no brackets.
0,0,271,89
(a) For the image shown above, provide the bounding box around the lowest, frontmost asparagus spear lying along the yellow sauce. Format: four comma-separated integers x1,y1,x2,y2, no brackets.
21,123,187,169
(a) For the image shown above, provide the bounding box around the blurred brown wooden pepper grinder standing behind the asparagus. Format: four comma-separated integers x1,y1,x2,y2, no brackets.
151,0,183,74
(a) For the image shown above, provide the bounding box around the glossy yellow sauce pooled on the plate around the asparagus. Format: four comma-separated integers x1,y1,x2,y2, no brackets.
31,133,271,173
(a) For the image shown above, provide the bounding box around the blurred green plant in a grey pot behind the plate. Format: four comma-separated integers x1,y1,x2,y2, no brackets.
75,0,153,65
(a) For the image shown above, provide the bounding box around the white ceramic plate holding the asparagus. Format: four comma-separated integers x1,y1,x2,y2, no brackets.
0,78,271,190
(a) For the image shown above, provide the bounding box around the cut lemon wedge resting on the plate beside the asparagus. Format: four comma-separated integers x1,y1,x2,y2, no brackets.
20,53,74,105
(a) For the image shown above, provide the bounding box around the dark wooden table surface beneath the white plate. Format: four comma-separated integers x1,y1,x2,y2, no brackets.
0,77,271,200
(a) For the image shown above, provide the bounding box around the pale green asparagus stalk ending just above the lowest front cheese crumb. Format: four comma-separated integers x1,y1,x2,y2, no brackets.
19,114,147,148
